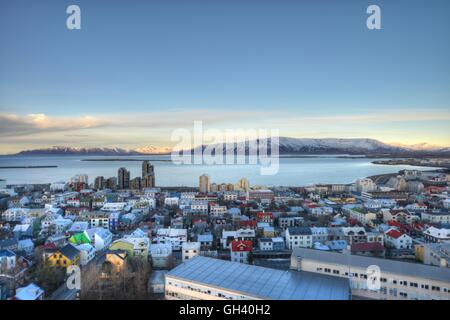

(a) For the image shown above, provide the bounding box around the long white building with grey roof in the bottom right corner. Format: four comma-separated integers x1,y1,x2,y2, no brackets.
291,248,450,300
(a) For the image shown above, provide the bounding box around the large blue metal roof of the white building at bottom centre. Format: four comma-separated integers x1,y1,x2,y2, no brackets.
167,256,350,300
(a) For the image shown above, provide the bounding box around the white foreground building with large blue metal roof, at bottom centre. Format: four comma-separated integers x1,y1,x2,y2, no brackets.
165,256,350,300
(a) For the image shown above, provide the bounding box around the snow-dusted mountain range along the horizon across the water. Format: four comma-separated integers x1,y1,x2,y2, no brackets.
10,137,450,156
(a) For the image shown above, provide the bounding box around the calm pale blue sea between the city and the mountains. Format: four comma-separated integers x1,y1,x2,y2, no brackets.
0,156,440,186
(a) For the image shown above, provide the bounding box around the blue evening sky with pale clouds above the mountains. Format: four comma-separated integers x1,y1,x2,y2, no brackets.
0,0,450,154
